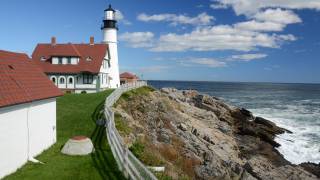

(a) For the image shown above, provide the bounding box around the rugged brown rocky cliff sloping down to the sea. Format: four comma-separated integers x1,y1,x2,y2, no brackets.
115,88,319,180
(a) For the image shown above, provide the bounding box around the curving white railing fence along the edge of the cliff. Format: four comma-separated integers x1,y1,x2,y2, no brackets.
104,81,157,180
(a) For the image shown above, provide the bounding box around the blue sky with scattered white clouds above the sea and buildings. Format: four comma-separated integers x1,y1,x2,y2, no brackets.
0,0,320,83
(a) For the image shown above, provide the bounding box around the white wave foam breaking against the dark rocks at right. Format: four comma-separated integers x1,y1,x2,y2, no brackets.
252,110,320,164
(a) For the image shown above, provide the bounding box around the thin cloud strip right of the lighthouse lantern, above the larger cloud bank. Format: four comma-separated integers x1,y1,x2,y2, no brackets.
137,12,214,25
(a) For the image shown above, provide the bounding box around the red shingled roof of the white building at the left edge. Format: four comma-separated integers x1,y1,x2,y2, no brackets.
0,50,62,107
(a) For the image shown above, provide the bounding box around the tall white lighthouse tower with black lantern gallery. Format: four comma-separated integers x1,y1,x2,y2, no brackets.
101,5,120,88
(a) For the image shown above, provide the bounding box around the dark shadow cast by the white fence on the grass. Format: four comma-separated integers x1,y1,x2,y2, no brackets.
91,101,125,179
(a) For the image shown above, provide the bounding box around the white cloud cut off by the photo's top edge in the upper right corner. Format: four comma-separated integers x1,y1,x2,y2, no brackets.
214,0,320,15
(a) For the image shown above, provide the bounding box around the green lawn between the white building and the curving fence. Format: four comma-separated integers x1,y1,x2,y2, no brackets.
5,90,124,180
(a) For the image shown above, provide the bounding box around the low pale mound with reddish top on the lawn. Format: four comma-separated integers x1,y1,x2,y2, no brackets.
61,136,94,156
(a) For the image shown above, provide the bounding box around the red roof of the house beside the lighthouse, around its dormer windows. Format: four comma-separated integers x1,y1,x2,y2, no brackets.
32,43,108,74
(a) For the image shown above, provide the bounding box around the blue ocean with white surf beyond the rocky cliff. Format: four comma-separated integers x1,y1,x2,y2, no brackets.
148,81,320,164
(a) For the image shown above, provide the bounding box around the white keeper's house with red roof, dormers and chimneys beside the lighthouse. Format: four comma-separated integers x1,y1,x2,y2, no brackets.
32,37,113,93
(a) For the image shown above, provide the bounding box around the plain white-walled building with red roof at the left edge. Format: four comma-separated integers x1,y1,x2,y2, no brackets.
0,50,62,179
